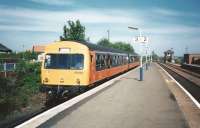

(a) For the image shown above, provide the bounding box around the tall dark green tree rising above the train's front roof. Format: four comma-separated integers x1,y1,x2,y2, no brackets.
60,20,85,41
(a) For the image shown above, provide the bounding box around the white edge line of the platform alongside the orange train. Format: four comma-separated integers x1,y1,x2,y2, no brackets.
16,66,139,128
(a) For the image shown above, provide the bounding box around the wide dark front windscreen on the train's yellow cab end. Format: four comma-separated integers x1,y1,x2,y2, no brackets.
44,54,84,70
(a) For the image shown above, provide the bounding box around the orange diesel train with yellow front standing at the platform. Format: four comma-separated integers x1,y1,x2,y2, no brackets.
41,41,139,96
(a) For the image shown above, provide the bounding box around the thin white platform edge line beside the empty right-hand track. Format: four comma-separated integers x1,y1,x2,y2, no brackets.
156,63,200,109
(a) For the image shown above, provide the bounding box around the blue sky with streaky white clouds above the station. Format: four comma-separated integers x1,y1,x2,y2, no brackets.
0,0,200,56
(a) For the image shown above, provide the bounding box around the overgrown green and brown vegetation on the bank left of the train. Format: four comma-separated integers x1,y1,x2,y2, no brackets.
0,52,43,120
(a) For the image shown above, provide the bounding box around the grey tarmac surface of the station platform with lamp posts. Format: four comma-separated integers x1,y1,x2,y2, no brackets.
39,64,189,128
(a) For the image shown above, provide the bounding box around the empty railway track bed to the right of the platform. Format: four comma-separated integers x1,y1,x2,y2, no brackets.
158,63,200,103
